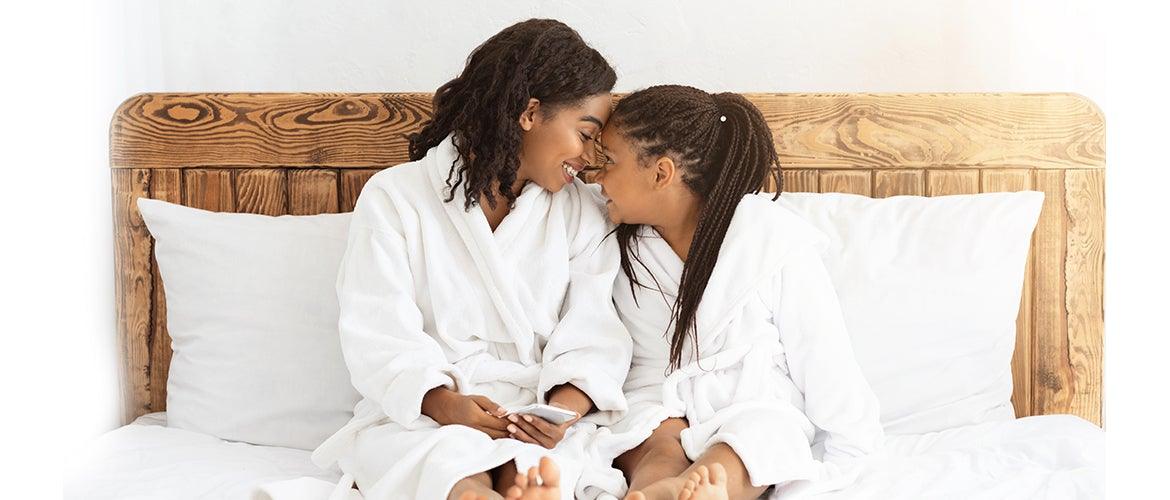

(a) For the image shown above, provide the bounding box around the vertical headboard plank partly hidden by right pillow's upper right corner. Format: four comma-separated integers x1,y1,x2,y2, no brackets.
980,170,1035,417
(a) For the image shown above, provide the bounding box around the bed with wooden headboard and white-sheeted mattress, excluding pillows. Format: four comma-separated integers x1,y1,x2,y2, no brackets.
67,94,1104,498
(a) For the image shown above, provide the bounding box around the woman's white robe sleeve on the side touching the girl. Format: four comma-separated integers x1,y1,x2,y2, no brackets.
537,189,633,423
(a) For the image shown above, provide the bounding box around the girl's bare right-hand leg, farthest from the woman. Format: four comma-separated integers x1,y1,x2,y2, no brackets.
679,443,768,500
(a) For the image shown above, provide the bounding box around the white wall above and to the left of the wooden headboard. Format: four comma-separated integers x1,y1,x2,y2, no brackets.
54,0,1108,448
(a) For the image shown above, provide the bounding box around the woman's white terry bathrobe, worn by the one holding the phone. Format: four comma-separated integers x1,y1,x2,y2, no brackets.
312,139,632,500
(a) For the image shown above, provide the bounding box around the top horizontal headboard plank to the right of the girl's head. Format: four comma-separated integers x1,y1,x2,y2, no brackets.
762,94,1104,170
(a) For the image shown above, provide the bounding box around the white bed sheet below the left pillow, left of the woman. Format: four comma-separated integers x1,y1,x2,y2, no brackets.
64,413,340,500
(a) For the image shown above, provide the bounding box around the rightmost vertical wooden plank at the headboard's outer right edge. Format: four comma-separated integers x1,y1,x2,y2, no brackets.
1065,170,1104,425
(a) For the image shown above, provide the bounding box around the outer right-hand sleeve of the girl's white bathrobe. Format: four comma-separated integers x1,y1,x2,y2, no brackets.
775,246,885,463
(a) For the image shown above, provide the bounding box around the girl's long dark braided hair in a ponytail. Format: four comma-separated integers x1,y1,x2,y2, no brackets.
610,85,782,370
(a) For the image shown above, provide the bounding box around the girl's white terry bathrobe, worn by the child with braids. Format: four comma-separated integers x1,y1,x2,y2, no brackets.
589,196,885,495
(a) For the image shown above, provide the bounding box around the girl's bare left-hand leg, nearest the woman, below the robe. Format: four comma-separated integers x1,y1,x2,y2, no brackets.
613,418,690,500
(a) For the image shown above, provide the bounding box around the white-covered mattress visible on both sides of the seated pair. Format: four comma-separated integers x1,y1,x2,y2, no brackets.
64,413,1104,500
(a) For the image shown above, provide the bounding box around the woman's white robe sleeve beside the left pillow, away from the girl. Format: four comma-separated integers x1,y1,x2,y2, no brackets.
337,186,459,425
